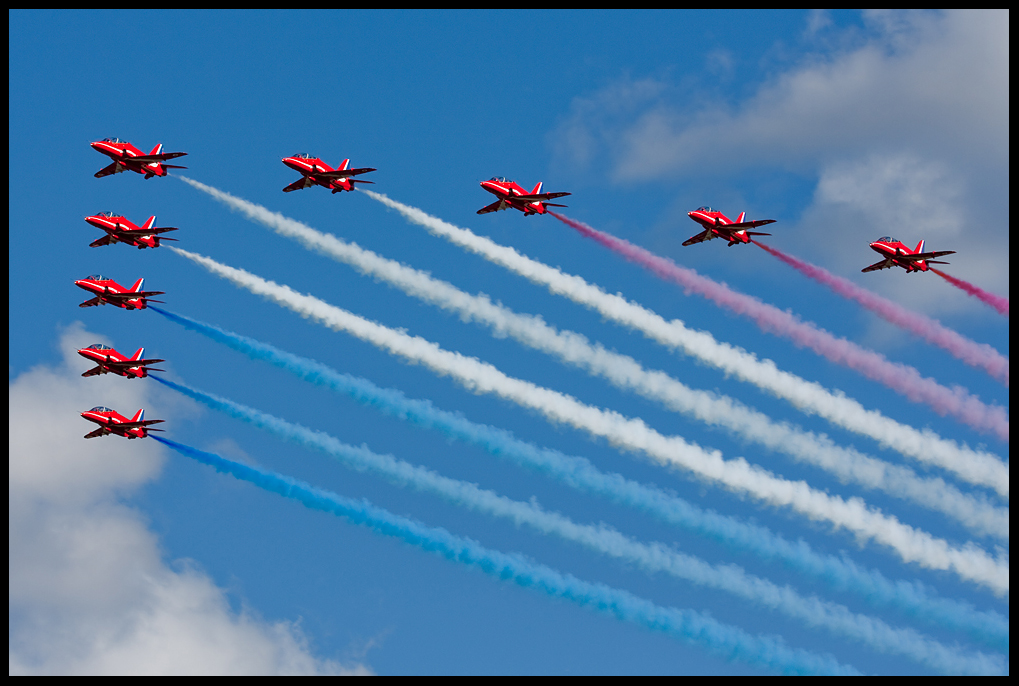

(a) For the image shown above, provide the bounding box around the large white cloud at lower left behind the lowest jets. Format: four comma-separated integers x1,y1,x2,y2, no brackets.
8,325,367,674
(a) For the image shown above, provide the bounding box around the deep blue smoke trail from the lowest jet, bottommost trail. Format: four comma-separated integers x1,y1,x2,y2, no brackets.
156,437,856,674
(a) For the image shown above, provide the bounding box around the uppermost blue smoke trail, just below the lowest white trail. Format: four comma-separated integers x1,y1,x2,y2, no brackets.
149,305,1009,650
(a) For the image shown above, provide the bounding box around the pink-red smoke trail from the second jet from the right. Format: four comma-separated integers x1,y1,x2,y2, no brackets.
754,241,1009,386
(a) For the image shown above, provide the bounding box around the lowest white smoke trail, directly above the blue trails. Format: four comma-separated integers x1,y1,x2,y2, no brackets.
170,247,1009,594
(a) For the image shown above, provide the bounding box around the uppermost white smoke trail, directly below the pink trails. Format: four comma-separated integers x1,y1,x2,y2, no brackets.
361,190,1009,497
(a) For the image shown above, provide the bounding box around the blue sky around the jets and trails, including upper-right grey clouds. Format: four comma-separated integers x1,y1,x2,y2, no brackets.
8,11,1009,674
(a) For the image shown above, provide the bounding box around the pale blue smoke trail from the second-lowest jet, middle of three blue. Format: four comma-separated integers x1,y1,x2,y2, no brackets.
153,376,1006,674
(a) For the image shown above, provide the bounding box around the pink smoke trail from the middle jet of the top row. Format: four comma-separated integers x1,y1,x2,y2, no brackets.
549,211,1009,441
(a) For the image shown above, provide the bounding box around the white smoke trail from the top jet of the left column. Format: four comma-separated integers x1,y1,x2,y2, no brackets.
171,178,1009,538
